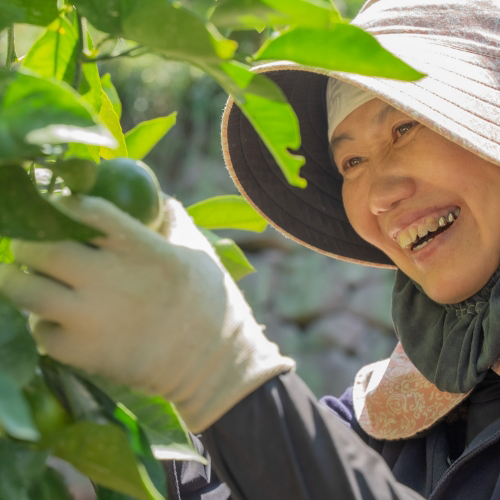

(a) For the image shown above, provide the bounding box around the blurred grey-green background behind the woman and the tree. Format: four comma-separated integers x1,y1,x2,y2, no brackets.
0,0,396,500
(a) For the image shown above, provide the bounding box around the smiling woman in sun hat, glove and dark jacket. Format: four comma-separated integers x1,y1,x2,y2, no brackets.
0,0,500,500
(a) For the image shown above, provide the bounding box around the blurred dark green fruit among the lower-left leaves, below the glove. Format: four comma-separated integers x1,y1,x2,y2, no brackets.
24,375,72,437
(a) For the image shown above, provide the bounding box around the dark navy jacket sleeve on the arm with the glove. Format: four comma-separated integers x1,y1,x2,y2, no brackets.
202,372,423,500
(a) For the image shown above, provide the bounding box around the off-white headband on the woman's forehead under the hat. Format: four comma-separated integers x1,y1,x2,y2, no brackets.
326,78,375,141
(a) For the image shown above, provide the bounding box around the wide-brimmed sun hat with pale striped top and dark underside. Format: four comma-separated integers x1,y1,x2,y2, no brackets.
222,0,500,268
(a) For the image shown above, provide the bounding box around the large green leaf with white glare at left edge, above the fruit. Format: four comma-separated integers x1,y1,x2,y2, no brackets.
0,69,115,164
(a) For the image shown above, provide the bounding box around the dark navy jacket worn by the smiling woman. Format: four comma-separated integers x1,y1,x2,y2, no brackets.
165,373,500,500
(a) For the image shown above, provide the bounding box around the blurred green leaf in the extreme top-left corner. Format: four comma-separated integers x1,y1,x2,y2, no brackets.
0,0,59,31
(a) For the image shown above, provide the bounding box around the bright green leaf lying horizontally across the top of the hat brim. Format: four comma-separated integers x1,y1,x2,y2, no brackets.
254,23,424,80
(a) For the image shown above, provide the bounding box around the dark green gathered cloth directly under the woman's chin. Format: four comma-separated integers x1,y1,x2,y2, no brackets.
392,269,500,393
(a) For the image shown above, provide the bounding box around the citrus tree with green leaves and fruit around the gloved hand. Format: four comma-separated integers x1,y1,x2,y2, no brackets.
0,0,421,500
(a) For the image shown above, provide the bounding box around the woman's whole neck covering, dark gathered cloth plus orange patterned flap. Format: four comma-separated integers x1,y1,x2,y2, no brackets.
353,268,500,440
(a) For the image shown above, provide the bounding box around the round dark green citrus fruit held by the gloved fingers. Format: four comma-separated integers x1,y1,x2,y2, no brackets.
86,158,162,227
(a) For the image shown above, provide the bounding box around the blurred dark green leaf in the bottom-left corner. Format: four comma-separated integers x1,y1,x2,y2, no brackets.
0,439,48,500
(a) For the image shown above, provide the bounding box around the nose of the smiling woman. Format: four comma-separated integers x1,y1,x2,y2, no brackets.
368,171,415,215
